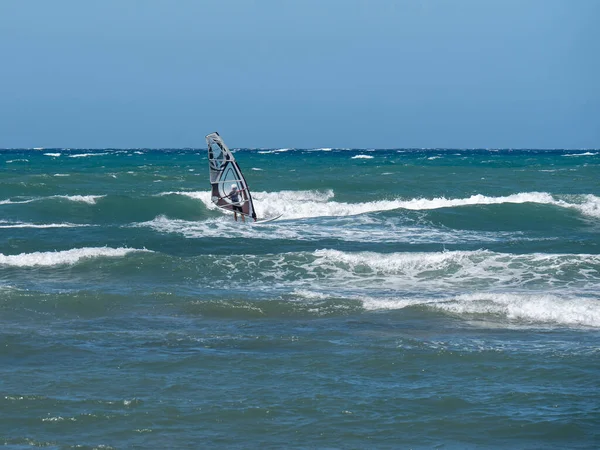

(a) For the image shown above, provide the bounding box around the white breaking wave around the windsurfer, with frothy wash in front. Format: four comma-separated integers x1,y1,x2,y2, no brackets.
133,190,600,244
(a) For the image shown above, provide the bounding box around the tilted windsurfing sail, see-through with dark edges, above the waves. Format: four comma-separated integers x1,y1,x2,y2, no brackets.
206,132,256,220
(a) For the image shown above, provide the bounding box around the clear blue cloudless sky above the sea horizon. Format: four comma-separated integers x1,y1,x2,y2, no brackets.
0,0,600,148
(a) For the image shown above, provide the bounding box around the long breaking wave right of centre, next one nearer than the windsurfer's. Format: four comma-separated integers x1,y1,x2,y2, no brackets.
213,249,600,298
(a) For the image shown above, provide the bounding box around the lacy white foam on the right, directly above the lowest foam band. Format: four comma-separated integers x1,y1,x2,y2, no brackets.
310,249,600,292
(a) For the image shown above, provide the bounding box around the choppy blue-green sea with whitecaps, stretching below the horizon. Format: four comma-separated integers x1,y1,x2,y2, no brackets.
0,148,600,449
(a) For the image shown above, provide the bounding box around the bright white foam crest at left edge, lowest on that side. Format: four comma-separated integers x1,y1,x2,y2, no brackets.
0,247,150,267
